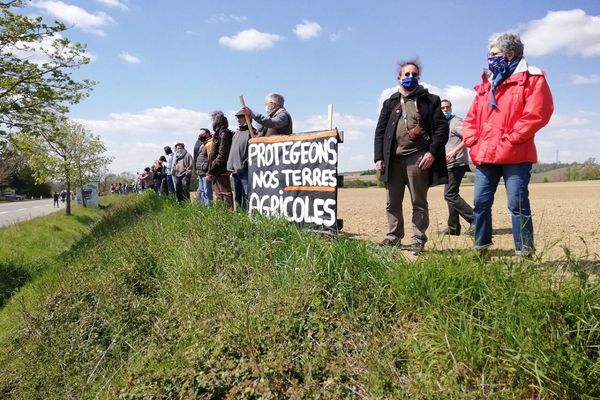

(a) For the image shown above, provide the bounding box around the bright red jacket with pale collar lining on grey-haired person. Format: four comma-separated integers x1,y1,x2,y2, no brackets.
462,58,554,165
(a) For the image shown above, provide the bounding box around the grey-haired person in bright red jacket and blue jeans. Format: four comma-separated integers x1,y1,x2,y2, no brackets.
463,33,554,256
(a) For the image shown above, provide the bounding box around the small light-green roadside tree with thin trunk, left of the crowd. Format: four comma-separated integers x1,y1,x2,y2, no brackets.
14,118,112,215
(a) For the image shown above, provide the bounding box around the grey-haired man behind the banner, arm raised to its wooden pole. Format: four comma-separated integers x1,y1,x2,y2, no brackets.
242,93,293,136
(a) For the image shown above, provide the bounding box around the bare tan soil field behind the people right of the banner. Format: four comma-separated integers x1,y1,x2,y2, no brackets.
338,181,600,260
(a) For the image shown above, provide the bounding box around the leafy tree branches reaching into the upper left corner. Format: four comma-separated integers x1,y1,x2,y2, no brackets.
0,0,94,137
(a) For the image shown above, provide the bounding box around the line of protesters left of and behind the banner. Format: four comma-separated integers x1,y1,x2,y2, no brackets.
130,93,292,210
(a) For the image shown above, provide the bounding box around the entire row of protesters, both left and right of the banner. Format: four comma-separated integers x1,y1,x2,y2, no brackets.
116,33,554,256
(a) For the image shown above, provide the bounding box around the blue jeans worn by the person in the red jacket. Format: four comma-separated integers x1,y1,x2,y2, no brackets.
473,163,533,254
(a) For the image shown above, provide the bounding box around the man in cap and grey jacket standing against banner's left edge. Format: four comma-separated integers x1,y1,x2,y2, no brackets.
227,110,250,210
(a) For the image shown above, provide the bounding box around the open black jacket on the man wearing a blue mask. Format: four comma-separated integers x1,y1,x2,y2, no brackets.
374,87,449,186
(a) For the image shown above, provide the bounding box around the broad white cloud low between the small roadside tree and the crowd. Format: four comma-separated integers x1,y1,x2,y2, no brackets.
76,106,210,172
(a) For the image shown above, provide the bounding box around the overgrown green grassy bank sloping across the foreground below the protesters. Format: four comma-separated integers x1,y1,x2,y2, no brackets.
0,193,600,399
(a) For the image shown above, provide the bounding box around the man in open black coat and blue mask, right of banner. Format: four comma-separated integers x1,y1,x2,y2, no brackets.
374,60,448,255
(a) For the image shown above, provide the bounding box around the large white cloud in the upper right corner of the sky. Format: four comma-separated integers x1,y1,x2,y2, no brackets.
521,9,600,57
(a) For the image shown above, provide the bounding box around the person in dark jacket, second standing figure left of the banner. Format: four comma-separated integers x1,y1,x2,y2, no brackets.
207,111,233,209
